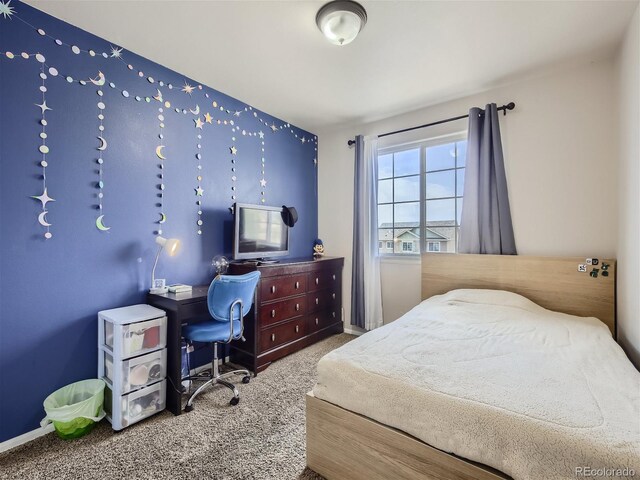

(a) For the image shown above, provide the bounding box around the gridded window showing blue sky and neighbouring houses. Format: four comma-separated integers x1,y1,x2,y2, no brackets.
378,135,467,255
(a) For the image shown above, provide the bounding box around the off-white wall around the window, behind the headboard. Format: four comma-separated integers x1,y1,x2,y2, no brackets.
318,60,618,328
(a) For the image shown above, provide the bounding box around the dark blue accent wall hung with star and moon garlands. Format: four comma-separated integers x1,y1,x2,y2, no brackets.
0,0,317,441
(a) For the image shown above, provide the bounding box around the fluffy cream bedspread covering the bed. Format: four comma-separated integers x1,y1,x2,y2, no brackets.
313,290,640,480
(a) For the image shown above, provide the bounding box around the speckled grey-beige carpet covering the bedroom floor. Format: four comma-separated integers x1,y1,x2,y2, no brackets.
0,334,354,480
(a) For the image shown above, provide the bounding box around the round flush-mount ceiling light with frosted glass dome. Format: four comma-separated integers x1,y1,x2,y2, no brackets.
316,0,367,45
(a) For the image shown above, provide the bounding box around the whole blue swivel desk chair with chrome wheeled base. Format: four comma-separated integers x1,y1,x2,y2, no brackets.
182,271,260,412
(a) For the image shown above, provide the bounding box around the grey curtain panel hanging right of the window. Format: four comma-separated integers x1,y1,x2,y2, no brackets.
458,103,517,255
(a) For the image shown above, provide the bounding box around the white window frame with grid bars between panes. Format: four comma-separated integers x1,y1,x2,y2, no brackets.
375,130,467,257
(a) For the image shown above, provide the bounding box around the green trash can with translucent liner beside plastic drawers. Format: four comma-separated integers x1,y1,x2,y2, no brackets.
40,379,105,440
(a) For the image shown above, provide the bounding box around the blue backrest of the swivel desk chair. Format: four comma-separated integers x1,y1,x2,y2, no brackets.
207,271,260,322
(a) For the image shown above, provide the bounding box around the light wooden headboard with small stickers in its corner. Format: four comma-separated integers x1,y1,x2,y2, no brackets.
422,253,616,338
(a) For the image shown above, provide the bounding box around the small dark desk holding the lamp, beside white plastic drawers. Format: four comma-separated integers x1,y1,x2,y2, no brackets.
147,285,211,415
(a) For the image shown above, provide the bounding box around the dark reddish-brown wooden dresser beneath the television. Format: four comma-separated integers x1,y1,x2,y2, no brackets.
229,257,344,374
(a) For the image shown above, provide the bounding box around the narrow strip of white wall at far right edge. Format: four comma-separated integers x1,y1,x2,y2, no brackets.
616,7,640,368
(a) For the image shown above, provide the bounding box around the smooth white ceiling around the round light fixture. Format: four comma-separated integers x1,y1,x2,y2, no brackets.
26,0,638,131
